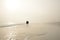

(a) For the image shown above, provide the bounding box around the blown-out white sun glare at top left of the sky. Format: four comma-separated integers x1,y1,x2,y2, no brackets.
6,0,18,10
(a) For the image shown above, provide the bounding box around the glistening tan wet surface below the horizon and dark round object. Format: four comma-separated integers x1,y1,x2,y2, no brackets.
0,23,60,40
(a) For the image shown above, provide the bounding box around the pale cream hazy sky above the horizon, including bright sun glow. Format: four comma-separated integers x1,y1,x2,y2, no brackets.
0,0,60,23
